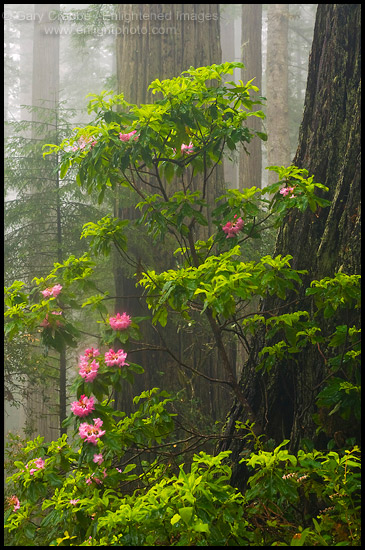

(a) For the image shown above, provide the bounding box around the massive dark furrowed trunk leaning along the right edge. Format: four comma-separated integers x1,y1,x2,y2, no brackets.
219,4,361,485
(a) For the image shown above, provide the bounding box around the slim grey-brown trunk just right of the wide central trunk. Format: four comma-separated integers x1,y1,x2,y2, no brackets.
239,4,262,189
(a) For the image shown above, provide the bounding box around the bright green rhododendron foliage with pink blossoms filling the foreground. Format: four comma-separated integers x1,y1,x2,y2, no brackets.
5,63,360,546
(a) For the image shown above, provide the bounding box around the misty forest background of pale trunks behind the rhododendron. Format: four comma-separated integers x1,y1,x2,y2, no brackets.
4,4,317,451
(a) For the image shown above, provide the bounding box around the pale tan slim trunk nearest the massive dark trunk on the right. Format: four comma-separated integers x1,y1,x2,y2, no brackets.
266,4,290,184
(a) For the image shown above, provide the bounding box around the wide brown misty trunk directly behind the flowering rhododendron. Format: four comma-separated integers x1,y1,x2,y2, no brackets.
114,4,227,420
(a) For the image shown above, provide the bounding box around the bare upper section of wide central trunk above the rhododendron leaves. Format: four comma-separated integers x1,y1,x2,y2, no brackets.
117,4,221,103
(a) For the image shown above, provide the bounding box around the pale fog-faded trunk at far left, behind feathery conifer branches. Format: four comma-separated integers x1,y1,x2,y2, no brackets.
27,4,61,440
